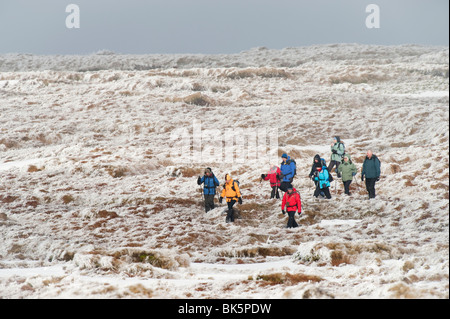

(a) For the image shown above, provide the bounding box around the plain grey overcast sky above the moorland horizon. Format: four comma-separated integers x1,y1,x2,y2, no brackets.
0,0,449,54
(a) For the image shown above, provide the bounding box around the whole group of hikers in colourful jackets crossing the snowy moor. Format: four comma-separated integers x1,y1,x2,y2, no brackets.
197,136,381,228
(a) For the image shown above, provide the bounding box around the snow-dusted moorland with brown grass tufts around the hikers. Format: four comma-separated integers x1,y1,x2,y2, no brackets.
0,44,449,298
